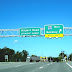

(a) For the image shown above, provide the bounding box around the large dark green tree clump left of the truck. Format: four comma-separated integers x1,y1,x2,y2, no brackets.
0,47,29,62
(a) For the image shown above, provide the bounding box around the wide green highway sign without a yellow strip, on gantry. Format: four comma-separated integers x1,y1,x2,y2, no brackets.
20,28,41,36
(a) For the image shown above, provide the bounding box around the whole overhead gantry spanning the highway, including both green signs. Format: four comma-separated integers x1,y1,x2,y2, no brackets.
0,24,72,38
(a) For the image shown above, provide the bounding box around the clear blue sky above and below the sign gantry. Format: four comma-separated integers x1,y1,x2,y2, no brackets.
0,0,72,57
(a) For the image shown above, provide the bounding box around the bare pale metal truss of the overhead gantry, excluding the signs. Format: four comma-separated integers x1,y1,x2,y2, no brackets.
0,27,72,37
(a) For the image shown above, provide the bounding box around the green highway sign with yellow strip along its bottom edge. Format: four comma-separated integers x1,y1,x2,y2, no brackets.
45,25,63,37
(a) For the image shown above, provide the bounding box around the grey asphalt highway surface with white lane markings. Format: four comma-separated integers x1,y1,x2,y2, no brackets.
0,62,72,72
